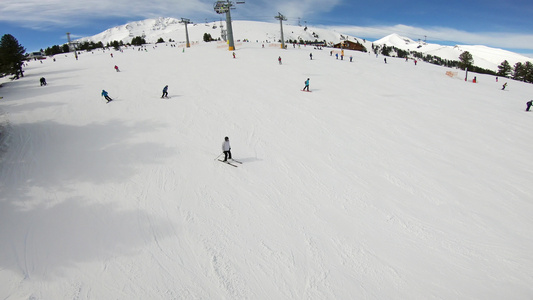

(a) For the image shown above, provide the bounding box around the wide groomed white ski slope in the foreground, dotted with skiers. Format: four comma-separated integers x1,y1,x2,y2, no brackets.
0,42,533,299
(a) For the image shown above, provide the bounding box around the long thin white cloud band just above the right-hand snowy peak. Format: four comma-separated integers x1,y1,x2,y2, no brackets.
327,25,533,50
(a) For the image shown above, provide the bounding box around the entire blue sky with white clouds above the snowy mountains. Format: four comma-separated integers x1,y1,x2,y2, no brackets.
0,0,533,57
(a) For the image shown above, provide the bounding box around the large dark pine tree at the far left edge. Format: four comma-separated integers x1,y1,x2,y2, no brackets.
0,34,26,79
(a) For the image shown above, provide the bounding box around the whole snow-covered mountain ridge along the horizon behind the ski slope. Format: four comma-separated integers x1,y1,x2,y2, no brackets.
78,17,533,71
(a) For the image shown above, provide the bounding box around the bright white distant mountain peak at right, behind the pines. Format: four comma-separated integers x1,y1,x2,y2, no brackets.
374,34,533,71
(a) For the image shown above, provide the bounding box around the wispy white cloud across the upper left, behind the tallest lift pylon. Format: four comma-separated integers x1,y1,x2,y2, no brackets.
0,0,343,29
